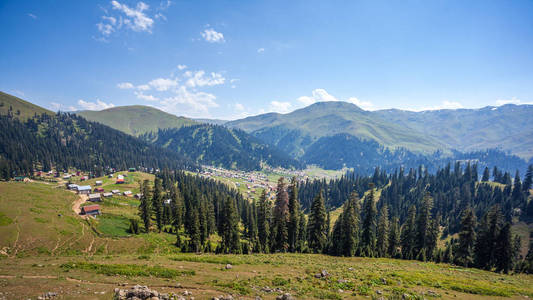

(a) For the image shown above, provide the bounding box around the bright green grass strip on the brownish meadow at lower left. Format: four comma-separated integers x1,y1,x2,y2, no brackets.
61,262,195,278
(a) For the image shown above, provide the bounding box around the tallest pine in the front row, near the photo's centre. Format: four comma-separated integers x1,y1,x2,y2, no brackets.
272,177,289,252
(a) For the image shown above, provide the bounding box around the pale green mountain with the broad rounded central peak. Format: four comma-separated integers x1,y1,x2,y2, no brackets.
225,102,444,157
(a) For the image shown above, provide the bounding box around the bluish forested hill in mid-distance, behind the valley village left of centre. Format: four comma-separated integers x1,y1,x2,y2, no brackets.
142,124,302,170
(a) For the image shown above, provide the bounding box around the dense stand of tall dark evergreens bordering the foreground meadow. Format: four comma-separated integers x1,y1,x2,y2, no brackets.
136,164,533,272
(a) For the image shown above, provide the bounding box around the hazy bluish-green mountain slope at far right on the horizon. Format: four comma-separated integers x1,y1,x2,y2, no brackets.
373,104,533,159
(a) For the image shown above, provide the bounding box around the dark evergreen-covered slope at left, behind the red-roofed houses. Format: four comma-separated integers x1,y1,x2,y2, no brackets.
0,113,197,180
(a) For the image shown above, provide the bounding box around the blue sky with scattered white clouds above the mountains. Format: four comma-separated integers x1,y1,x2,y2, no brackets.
0,0,533,119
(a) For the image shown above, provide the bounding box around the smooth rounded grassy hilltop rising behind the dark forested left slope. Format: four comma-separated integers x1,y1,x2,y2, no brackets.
76,105,197,136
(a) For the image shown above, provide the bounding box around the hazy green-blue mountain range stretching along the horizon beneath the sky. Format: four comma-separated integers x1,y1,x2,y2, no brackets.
0,89,533,172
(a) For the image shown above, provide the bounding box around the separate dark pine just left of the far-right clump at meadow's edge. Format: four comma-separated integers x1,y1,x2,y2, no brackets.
455,208,476,267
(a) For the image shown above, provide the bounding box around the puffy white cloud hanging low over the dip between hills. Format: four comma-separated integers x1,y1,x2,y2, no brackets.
160,86,218,117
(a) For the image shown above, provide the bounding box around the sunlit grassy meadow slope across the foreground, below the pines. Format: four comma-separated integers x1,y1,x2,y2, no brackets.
0,182,533,299
